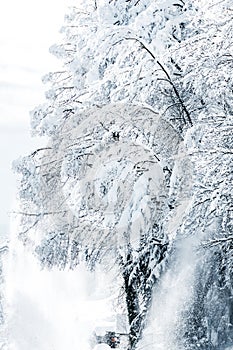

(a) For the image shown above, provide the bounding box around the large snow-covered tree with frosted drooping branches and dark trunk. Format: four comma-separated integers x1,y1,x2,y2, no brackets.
14,0,233,349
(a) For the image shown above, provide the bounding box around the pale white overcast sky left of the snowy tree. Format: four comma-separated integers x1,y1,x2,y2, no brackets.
0,0,73,236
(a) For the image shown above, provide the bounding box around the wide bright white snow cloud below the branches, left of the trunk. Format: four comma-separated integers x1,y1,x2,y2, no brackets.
6,226,115,350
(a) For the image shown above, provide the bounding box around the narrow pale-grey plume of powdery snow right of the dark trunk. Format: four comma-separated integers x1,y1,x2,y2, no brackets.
137,237,198,350
